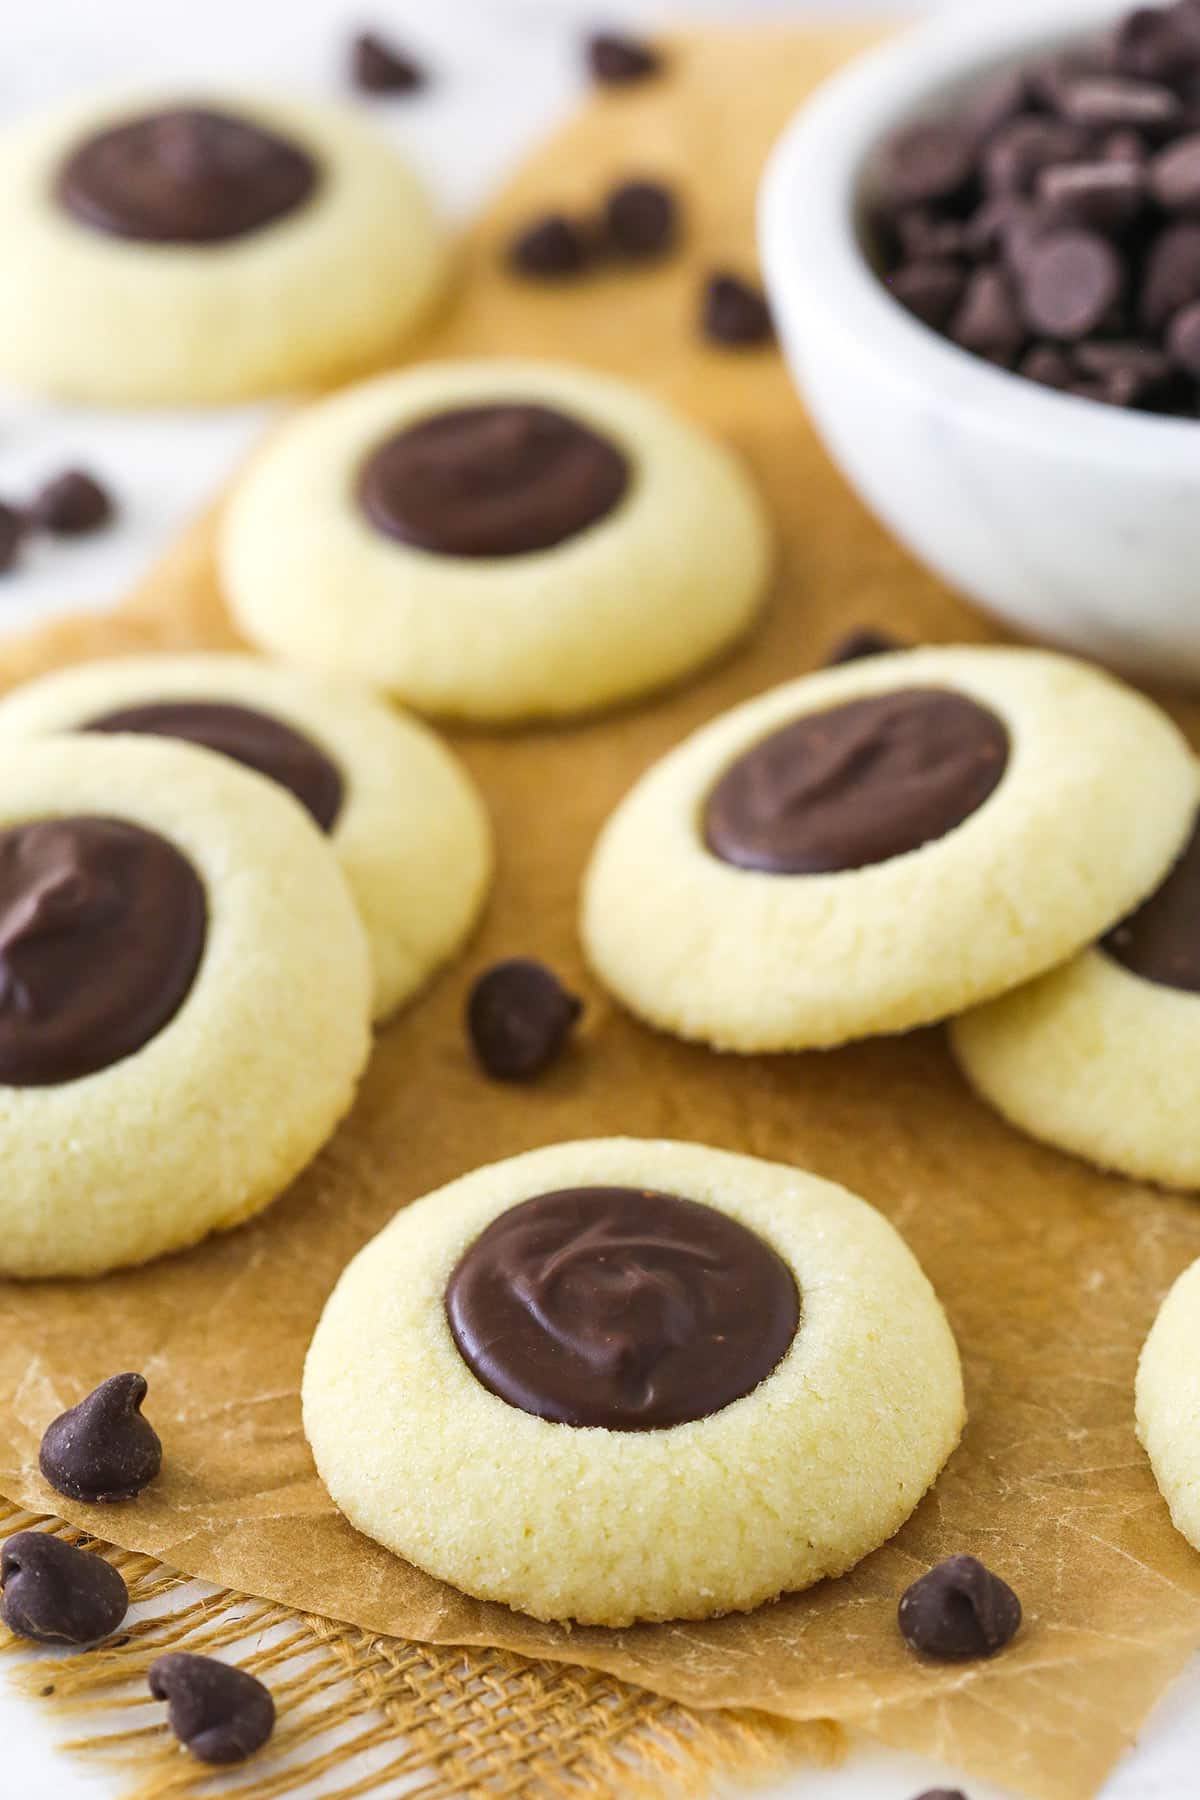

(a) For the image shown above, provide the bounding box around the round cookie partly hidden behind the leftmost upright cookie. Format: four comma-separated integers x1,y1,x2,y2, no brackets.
0,653,491,1019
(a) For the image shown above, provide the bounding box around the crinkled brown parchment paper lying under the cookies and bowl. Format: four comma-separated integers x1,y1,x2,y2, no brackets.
0,31,1200,1800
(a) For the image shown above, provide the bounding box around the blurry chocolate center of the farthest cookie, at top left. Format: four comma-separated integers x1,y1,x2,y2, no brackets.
58,106,318,246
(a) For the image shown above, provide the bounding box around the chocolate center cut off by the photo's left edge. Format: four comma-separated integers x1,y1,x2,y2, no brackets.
0,817,209,1087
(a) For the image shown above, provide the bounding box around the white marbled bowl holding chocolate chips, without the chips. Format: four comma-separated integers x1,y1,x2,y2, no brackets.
759,0,1200,684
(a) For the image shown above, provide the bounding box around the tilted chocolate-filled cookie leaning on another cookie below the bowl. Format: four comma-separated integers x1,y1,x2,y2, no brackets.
583,648,1198,1051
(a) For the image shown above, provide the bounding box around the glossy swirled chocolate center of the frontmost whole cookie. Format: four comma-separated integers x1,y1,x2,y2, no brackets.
446,1188,801,1431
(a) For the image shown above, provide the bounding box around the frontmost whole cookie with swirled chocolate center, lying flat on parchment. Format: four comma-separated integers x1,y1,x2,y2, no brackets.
304,1138,964,1625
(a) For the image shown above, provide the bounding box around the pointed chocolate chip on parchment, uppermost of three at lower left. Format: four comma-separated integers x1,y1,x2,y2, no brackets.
38,1375,162,1501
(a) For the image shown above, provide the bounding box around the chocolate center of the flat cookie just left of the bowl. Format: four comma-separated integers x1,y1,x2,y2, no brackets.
358,403,630,556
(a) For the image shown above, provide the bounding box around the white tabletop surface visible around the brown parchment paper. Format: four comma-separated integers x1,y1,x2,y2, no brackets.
0,0,1200,1800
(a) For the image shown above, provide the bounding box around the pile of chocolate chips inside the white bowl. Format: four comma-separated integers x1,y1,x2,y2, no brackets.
873,0,1200,418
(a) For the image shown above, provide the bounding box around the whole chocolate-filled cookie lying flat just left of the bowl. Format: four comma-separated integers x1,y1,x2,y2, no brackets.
219,360,770,722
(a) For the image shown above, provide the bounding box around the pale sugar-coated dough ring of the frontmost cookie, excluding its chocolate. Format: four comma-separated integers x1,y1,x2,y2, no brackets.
304,1139,964,1625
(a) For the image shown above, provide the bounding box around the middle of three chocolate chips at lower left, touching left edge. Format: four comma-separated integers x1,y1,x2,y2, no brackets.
0,1532,130,1643
